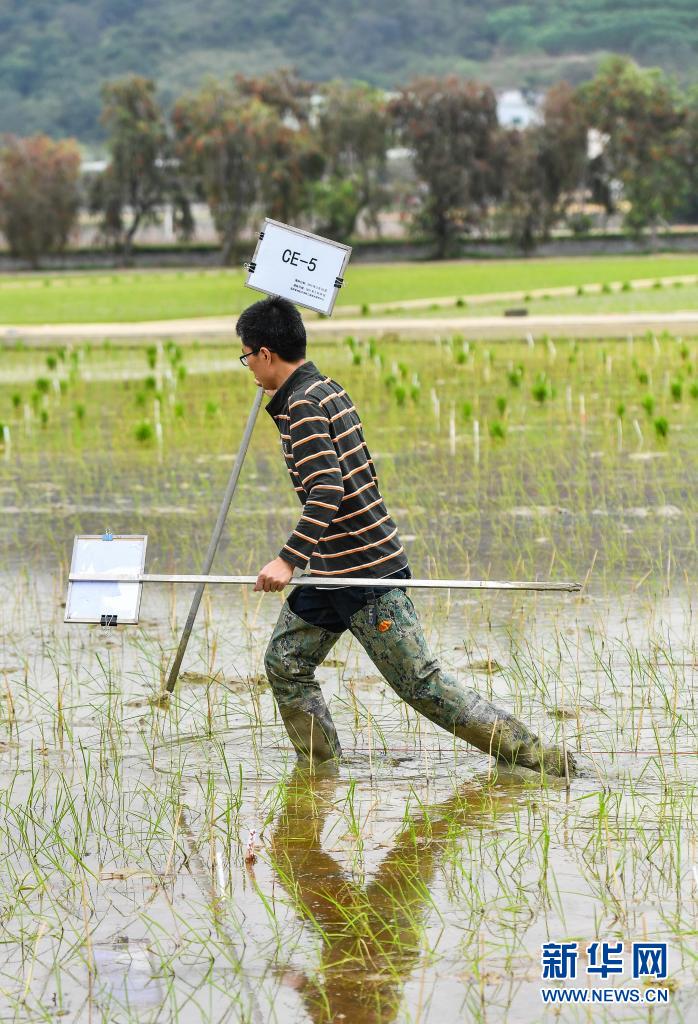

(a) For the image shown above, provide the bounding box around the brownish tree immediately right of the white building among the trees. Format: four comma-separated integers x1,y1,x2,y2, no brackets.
499,82,586,252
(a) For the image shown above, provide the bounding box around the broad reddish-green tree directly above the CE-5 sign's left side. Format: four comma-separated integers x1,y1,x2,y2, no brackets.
172,82,324,262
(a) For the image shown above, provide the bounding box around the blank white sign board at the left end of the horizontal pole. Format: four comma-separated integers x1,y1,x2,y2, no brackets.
66,536,147,625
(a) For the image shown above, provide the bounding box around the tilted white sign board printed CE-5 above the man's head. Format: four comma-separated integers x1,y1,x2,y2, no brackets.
245,217,351,316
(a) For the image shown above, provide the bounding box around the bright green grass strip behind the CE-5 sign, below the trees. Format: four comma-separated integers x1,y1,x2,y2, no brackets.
0,254,698,324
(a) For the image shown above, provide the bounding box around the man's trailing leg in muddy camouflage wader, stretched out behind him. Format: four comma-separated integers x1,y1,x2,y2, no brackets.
350,590,576,775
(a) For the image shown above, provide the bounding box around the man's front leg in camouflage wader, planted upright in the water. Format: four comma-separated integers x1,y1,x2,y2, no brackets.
264,601,342,762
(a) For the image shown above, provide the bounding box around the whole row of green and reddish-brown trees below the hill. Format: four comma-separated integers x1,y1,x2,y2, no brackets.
0,56,698,264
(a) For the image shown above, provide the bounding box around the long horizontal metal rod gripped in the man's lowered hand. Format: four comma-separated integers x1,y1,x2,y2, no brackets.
68,572,582,598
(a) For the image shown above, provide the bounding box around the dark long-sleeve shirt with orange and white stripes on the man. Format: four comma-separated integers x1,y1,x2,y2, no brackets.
266,361,407,578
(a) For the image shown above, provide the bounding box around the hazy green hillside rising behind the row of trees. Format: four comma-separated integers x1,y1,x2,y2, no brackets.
0,0,698,142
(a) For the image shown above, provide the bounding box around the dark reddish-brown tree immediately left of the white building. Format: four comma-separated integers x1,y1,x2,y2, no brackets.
390,77,504,256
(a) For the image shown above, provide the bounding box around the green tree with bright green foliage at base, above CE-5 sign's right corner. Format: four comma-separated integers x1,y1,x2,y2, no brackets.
314,82,391,238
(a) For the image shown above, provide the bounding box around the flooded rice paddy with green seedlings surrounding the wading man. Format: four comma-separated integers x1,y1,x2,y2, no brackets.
0,336,698,1024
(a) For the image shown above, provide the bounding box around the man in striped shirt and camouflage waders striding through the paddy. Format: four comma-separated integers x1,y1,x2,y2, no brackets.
235,298,575,775
